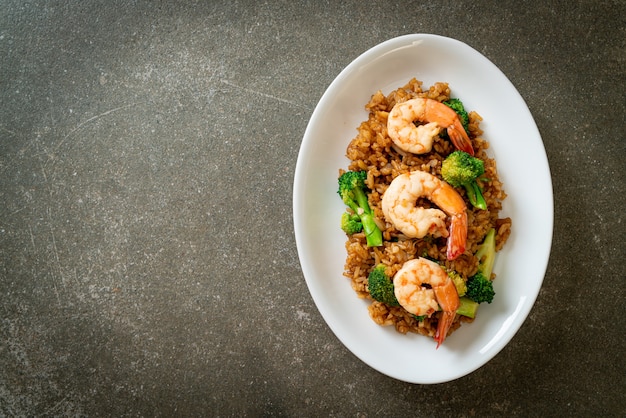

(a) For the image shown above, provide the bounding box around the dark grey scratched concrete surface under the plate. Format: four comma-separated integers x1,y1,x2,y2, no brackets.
0,0,626,417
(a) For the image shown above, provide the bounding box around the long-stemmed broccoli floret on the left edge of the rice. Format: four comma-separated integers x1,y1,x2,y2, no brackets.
337,171,383,247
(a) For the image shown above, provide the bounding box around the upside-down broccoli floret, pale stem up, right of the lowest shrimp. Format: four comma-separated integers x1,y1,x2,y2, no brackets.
465,228,496,303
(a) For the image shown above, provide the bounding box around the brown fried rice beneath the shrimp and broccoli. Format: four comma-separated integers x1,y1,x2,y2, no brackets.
339,78,511,337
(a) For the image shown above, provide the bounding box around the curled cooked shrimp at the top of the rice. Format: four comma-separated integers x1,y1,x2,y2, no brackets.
387,99,474,155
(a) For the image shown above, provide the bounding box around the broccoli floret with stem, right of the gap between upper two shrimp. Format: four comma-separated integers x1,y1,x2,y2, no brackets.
441,150,487,210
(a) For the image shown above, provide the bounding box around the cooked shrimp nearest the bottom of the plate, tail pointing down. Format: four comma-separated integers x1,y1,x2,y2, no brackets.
393,258,460,348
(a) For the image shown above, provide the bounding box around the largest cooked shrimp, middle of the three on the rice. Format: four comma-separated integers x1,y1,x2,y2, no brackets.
382,171,467,260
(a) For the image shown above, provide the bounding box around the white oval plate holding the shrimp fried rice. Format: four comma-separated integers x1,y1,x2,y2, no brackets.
293,34,553,384
